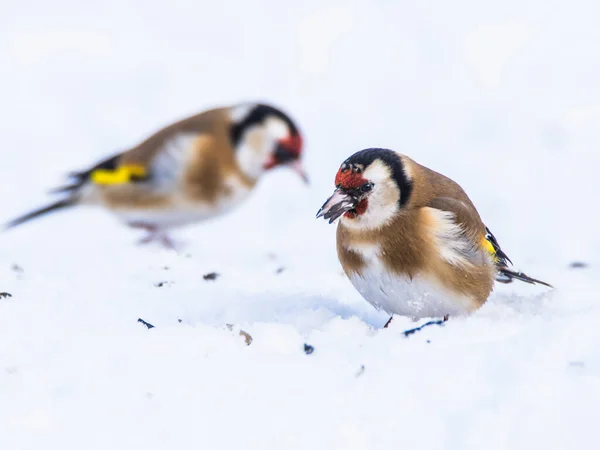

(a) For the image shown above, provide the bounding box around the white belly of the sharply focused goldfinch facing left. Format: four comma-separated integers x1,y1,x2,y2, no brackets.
349,246,475,319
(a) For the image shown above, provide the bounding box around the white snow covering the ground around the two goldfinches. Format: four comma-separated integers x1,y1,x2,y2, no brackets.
0,0,600,450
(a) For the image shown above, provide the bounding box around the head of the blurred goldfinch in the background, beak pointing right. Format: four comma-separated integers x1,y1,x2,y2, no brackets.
229,103,308,183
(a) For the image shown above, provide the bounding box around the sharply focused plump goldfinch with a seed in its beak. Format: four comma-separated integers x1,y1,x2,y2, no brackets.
317,148,552,327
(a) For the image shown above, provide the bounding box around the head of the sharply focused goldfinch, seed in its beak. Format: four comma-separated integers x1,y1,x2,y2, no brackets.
317,148,413,229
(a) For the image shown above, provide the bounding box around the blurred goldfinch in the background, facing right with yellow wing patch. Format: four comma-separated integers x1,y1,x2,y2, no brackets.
5,102,308,248
